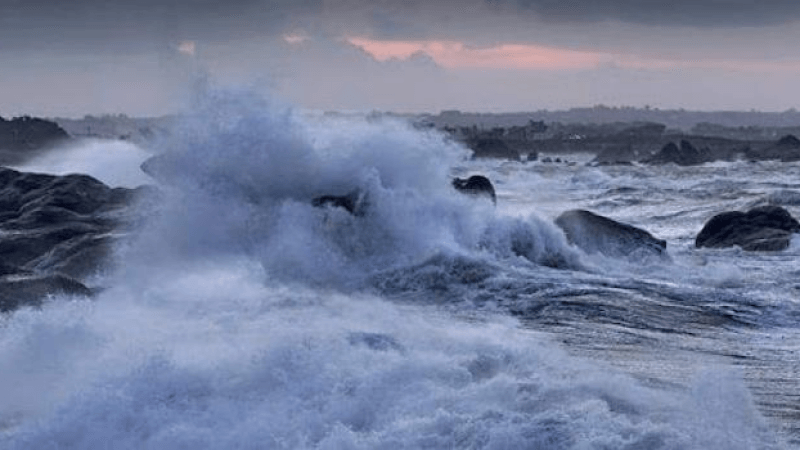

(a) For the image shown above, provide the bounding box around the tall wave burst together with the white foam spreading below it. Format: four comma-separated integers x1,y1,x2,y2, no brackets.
0,87,781,449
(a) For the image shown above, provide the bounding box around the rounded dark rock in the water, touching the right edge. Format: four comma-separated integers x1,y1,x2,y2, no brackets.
695,206,800,251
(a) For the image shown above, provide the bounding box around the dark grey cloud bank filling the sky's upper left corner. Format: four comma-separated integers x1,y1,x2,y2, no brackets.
0,0,321,51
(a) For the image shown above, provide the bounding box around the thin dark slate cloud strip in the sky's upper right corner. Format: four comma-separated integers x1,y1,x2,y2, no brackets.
486,0,800,27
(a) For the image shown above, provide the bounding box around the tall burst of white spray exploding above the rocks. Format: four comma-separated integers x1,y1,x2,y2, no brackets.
130,86,577,288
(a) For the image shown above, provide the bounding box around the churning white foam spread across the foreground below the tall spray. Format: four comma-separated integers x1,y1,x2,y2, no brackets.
0,276,778,449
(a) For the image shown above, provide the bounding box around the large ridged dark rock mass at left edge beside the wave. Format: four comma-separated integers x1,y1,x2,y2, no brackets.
0,168,149,311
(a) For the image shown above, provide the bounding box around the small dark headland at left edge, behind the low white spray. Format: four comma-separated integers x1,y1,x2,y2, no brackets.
0,116,69,164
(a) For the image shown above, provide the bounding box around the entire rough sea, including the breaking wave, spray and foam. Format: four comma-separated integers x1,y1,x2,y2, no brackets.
0,90,800,450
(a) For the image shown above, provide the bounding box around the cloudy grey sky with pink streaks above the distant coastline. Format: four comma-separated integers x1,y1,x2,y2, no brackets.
0,0,800,117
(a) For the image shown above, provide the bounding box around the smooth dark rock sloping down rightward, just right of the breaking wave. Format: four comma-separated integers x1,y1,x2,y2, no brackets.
555,209,667,258
